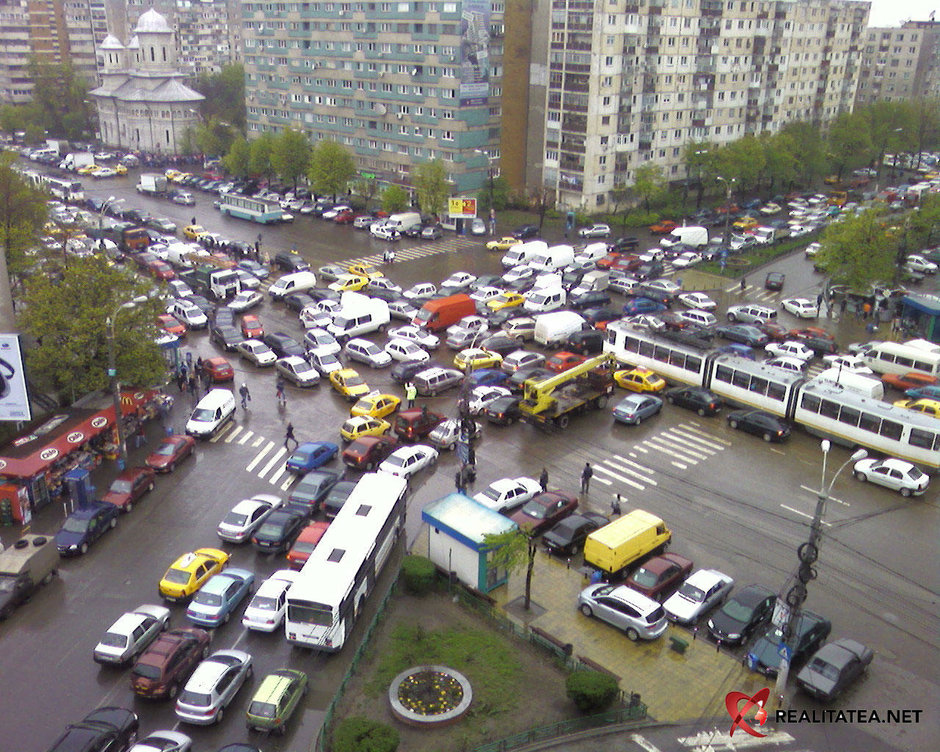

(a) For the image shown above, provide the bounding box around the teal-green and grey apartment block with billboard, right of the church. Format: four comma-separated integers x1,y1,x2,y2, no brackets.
241,0,503,194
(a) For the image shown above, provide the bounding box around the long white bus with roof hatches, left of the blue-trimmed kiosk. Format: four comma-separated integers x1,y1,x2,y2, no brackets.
284,473,408,652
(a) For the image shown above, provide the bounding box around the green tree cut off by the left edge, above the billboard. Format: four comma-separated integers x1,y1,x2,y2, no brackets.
0,152,47,332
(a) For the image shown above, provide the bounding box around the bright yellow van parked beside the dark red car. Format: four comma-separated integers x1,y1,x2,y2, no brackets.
584,509,672,576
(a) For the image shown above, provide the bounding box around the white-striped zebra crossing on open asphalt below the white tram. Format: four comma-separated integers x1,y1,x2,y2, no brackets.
593,421,731,491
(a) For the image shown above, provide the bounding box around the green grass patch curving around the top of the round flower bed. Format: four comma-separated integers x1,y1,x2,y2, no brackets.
365,624,525,716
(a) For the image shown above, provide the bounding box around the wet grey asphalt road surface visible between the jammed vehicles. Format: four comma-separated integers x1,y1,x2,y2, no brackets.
0,172,940,752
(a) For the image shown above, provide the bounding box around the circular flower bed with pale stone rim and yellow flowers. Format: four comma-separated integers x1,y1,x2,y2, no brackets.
388,666,473,726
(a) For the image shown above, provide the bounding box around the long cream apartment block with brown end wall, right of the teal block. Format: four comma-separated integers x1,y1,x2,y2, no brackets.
510,0,870,211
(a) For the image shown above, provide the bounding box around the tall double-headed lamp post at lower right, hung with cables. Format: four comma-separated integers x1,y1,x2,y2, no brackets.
774,439,868,705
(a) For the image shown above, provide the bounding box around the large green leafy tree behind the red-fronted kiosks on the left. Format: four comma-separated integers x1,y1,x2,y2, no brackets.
22,256,166,399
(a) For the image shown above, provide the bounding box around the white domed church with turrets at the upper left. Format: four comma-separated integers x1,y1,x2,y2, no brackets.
91,8,205,154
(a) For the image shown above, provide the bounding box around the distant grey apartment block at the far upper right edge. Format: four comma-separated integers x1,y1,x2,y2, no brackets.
855,20,940,104
